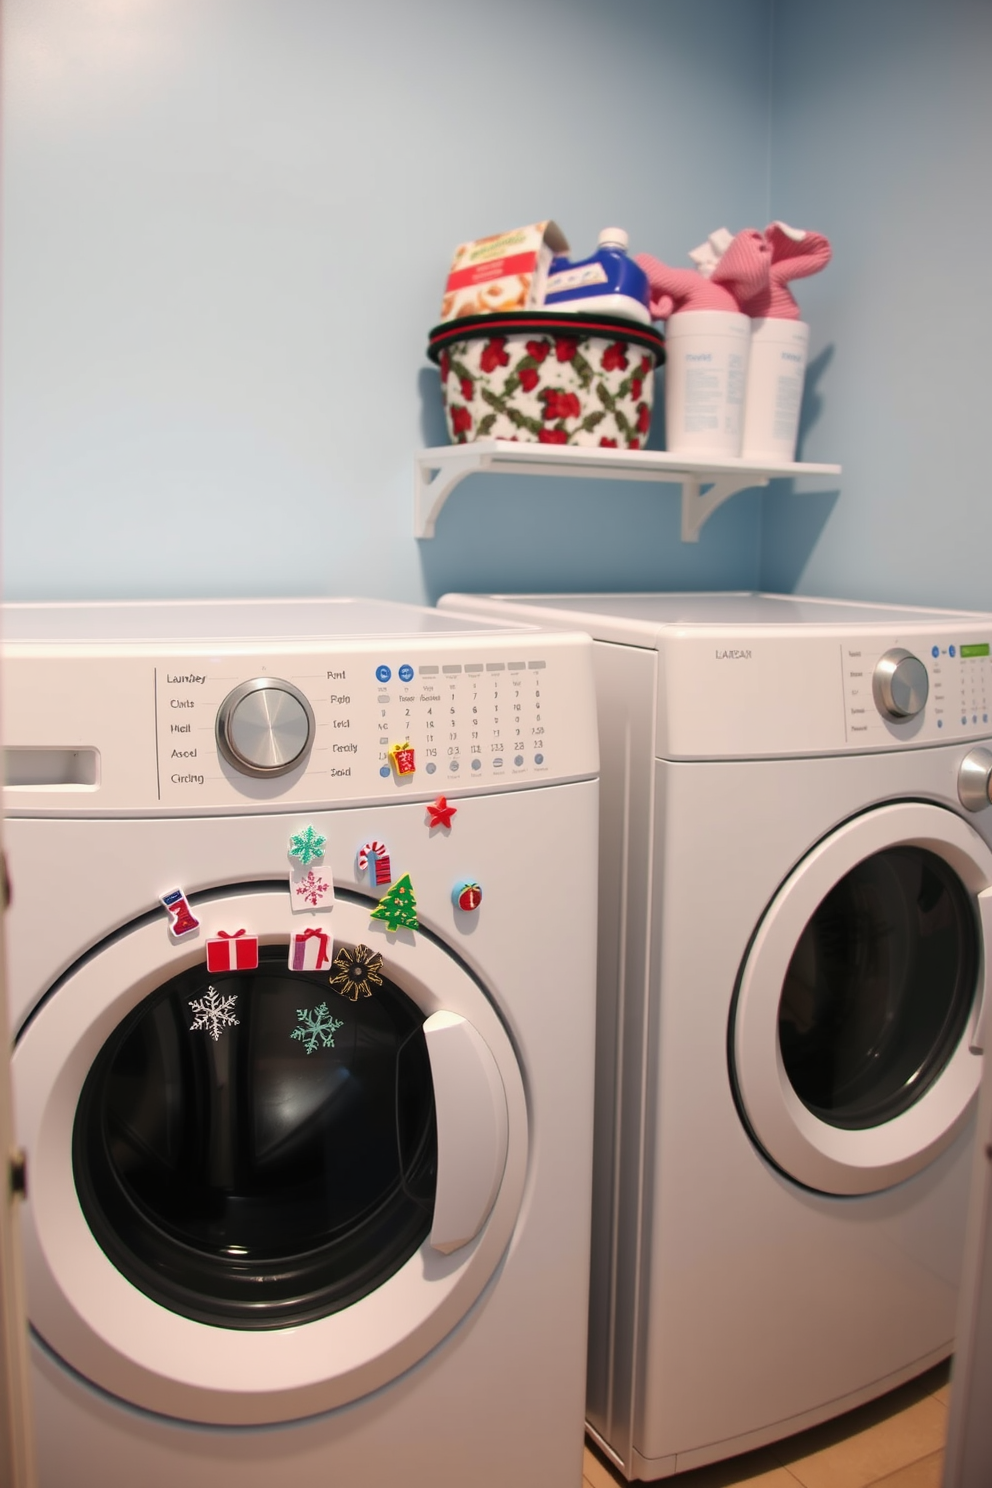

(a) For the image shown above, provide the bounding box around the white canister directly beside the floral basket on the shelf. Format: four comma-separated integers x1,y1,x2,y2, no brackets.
665,310,751,457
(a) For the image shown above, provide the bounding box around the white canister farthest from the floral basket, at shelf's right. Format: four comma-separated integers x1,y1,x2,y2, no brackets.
741,318,809,463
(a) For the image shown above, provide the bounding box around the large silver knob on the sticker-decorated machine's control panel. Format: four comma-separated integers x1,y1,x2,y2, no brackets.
217,677,314,777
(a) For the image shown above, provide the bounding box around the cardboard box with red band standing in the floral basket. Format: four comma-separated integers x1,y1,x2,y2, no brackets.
440,222,568,321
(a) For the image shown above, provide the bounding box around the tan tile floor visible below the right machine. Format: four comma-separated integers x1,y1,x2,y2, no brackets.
583,1363,950,1488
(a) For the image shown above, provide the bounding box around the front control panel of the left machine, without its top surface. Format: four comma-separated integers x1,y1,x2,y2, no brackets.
4,631,598,815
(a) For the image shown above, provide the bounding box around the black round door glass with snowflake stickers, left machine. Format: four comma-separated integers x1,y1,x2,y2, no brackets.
73,946,437,1329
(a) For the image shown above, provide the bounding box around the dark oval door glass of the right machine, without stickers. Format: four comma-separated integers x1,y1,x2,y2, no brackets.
778,847,979,1129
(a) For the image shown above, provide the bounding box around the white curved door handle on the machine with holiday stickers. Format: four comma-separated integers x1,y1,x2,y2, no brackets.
424,1012,507,1254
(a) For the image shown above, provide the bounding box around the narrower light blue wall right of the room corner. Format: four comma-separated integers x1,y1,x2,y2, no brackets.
761,0,992,609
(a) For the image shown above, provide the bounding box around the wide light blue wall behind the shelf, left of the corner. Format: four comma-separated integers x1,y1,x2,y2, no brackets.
3,0,773,600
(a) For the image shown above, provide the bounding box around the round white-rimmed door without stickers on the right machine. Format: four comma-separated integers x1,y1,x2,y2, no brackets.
730,802,992,1193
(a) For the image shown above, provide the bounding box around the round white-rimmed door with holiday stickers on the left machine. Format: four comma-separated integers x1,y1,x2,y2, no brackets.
13,885,528,1424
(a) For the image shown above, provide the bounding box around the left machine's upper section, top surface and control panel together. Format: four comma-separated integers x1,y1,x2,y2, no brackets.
1,598,598,815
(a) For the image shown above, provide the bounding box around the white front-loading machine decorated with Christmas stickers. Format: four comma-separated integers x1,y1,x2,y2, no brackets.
3,600,598,1488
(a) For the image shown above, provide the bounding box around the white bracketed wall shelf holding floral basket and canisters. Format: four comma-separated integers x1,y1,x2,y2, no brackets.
413,439,840,543
